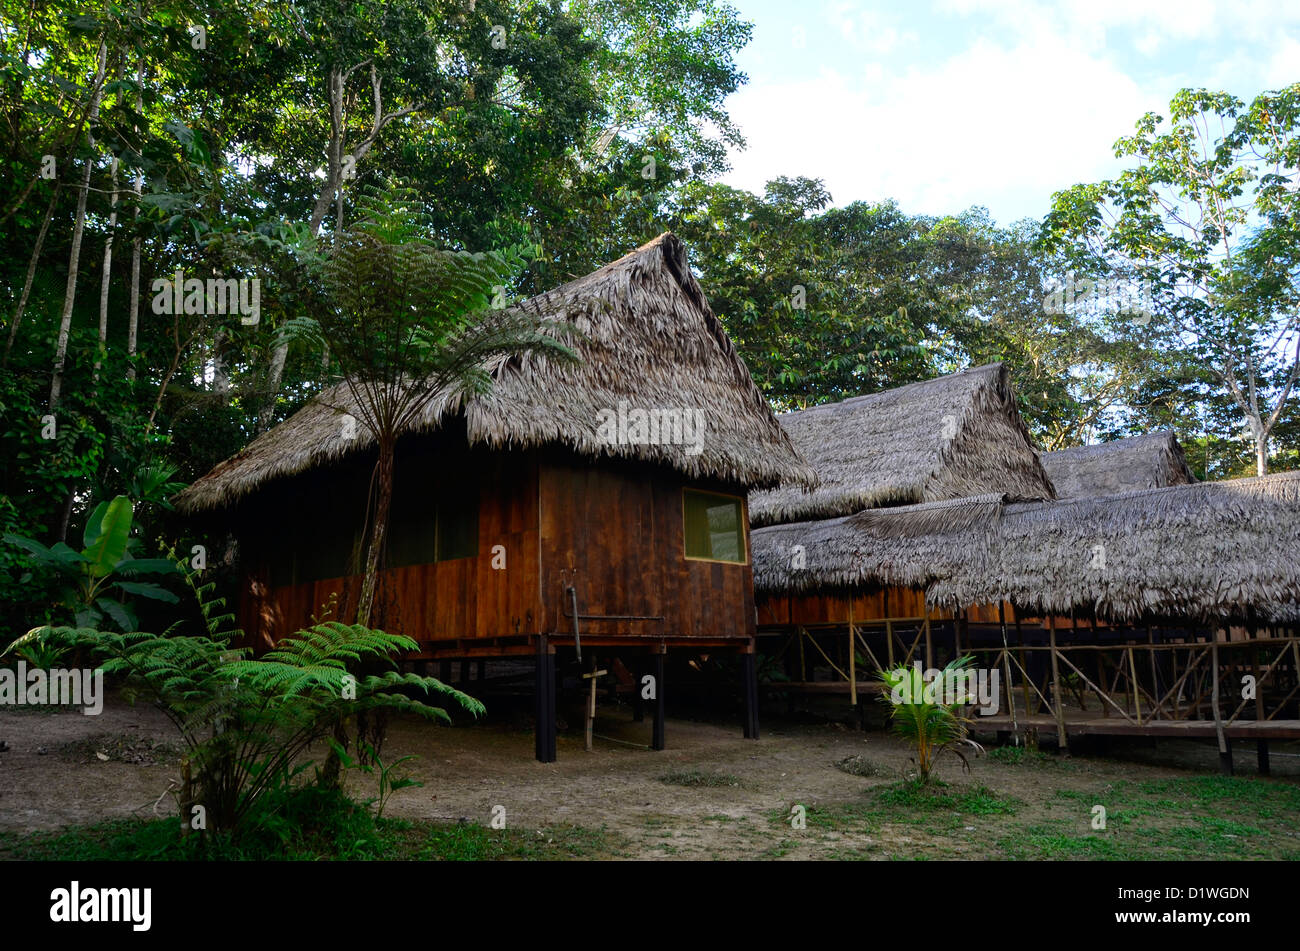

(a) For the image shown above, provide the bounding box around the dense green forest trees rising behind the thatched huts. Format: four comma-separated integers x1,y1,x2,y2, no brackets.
0,0,1300,624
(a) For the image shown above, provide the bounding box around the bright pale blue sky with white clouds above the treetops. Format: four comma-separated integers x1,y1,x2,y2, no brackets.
724,0,1300,225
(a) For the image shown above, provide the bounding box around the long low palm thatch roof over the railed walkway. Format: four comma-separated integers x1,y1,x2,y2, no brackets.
753,472,1300,622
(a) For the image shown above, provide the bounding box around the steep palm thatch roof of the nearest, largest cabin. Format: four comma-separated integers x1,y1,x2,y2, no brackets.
177,234,816,512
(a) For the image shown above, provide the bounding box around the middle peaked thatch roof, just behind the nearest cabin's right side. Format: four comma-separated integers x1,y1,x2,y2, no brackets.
749,364,1054,526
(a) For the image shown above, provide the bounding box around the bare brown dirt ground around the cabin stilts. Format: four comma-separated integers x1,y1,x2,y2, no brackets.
0,698,1300,859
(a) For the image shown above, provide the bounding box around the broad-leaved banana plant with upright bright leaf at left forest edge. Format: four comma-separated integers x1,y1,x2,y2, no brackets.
4,495,179,631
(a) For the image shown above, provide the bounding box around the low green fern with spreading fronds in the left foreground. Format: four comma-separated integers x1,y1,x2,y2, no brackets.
18,563,484,838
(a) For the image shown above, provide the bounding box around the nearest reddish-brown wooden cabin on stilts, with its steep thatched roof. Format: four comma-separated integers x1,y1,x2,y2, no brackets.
178,234,816,763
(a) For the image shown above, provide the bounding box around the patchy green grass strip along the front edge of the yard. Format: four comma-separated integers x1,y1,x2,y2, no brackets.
10,760,1300,861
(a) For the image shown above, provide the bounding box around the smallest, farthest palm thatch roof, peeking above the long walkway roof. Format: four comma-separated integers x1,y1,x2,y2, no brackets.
1041,430,1196,499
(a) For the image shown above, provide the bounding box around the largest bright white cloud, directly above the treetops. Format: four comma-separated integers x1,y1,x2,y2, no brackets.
728,27,1158,220
